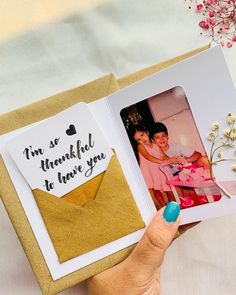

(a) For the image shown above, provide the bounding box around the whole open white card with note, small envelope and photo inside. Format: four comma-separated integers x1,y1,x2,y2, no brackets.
0,47,236,280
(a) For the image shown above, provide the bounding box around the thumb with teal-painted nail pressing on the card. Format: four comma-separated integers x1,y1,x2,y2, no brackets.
128,202,180,275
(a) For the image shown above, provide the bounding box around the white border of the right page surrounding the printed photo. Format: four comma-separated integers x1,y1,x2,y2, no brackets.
108,46,236,224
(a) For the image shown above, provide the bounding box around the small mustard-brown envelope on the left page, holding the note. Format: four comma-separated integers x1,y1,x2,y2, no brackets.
33,155,145,263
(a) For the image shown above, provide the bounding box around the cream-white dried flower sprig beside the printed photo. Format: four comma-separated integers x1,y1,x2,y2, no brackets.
207,113,236,197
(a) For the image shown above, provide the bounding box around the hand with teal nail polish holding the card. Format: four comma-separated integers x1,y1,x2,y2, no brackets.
88,202,180,295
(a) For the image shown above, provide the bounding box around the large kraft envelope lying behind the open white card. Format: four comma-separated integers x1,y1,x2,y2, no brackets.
0,45,209,295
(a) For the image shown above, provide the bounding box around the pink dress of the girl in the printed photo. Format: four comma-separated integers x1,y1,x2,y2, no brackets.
139,144,171,192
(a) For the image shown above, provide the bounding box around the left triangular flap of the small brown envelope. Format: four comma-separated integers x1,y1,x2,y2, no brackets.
33,189,81,254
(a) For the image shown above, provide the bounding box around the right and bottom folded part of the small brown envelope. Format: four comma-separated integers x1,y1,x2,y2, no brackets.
58,155,145,263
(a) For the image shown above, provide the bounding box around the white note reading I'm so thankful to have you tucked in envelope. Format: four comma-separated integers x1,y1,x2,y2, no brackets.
7,103,112,197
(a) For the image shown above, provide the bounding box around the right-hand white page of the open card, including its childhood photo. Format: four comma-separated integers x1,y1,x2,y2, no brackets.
107,47,236,224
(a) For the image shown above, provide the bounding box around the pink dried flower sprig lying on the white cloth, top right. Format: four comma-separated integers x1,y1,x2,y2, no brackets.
185,0,236,48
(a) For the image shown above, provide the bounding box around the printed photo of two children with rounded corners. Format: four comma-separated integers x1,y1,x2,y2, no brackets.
120,86,221,210
